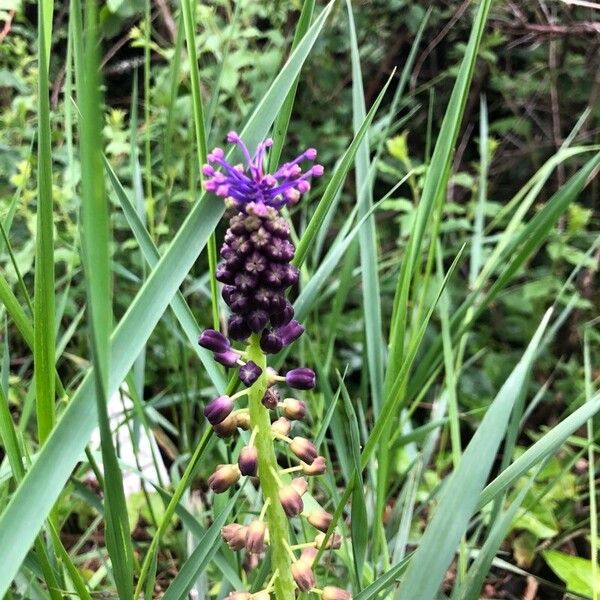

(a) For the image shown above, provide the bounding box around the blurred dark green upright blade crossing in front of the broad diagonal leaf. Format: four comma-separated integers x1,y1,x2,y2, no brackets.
76,0,133,600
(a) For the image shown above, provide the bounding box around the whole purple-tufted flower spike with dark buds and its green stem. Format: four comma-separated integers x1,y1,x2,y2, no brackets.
199,132,350,600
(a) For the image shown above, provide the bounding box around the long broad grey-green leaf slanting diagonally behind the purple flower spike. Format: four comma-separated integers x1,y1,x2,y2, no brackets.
0,4,332,597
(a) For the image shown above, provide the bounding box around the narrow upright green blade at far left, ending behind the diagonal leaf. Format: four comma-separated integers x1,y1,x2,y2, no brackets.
33,0,56,444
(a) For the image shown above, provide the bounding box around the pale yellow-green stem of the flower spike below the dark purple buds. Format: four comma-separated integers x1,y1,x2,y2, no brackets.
247,335,295,600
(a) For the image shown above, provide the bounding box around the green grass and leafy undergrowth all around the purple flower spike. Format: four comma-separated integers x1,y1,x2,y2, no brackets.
0,0,600,600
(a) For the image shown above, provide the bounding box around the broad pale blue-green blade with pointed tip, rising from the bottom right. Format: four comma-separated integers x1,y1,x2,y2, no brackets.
397,311,551,600
